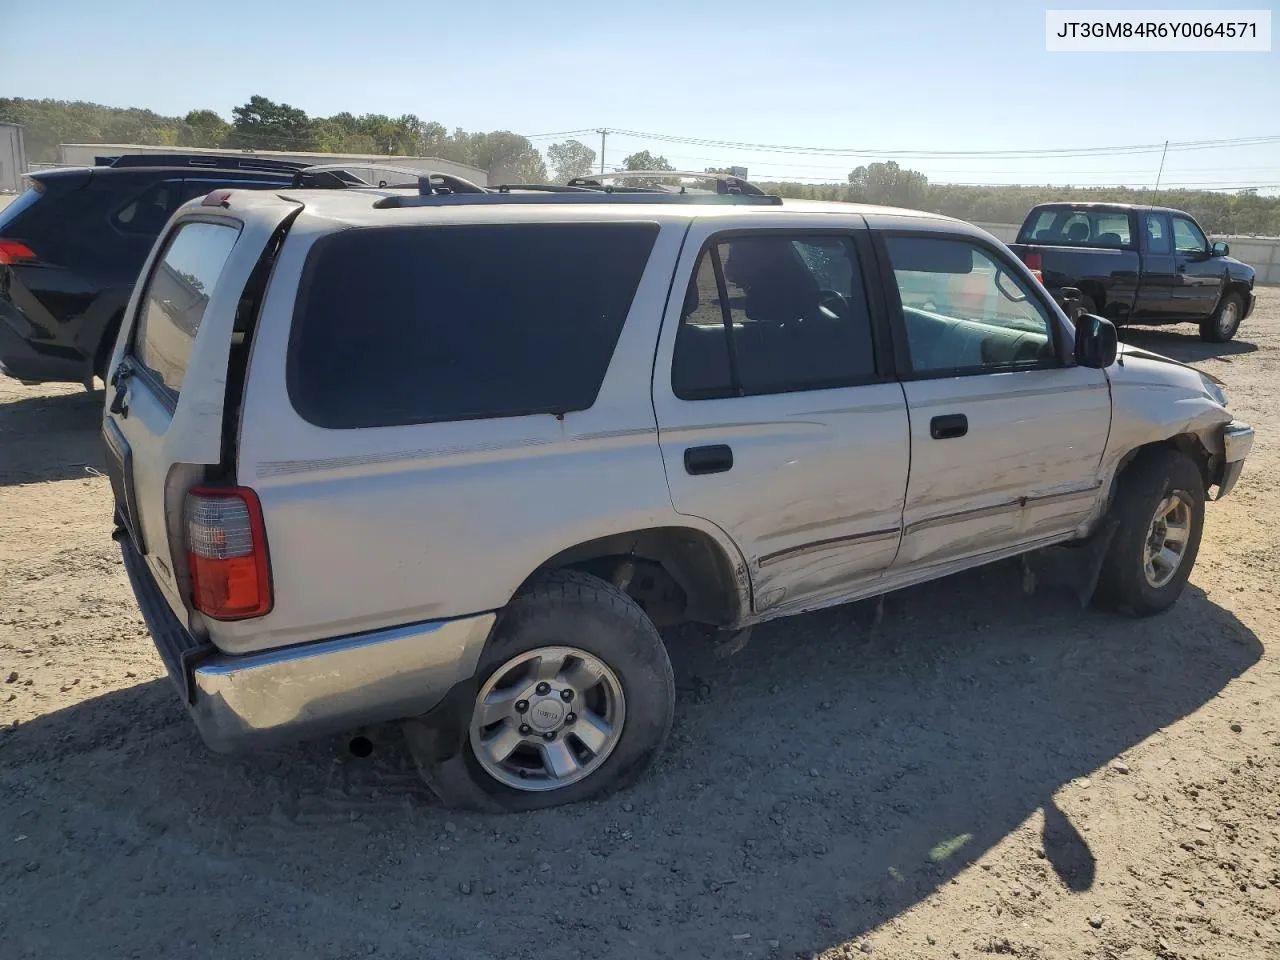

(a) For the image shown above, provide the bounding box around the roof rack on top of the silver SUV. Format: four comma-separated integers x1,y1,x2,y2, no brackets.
374,170,782,210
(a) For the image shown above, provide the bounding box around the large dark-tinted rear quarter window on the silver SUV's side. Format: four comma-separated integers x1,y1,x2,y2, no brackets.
288,223,658,429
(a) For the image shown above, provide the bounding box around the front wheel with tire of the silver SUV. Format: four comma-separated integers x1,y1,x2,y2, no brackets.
1098,449,1204,617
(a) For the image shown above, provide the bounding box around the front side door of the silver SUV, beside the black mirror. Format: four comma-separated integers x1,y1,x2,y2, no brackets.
881,233,1111,571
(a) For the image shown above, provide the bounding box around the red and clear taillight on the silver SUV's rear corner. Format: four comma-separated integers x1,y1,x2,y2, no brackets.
187,486,271,620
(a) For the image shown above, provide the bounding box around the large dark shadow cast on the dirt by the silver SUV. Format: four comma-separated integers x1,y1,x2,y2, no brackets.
0,564,1262,957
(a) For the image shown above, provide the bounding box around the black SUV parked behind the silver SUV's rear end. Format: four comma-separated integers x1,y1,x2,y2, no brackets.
0,154,306,387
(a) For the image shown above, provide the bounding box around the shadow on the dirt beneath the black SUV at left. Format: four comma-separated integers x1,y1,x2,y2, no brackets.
0,390,104,486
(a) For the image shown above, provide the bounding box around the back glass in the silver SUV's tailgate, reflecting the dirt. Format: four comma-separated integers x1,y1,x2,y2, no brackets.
133,221,239,399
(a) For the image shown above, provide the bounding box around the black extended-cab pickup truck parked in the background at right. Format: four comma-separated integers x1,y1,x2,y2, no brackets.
1010,204,1254,343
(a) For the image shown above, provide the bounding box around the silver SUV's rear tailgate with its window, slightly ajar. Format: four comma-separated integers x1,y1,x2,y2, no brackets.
104,201,297,618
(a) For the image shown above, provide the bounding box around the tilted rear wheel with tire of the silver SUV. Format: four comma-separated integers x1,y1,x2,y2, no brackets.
406,571,676,813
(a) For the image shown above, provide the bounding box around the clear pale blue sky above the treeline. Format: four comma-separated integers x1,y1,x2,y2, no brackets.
0,0,1280,192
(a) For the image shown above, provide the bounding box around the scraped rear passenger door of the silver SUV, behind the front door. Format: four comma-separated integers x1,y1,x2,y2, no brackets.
653,216,909,612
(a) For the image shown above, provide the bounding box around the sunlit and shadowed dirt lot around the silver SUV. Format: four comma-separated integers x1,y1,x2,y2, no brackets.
0,296,1280,960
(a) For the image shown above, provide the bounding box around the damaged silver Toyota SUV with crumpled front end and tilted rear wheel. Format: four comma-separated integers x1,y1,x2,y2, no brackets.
104,174,1253,810
